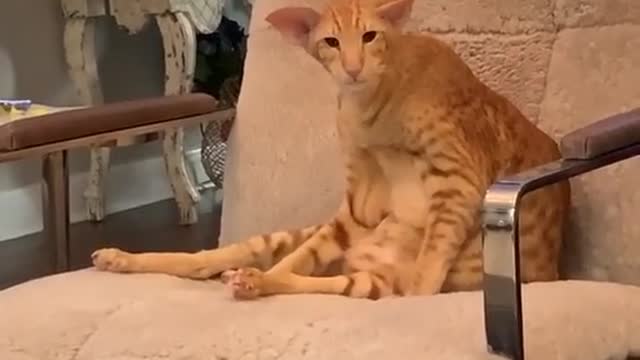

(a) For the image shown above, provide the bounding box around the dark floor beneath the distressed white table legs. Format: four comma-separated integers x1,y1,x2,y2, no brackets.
0,190,221,289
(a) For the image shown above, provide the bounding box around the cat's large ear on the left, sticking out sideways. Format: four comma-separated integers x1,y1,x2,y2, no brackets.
266,7,320,47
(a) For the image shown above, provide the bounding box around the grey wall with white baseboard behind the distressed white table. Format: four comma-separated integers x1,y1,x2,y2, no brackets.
0,0,208,240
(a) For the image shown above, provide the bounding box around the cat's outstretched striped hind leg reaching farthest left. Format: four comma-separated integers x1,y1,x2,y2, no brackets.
91,226,323,279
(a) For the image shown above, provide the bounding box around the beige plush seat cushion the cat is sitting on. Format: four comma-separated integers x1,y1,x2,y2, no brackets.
0,269,640,360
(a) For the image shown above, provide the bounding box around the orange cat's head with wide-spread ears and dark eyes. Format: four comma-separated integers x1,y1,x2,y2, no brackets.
266,0,414,90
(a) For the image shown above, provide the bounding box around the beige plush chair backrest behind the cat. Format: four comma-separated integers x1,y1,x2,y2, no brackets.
222,0,640,284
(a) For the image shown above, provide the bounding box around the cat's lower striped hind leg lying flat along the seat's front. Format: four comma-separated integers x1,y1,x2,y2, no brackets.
222,268,400,300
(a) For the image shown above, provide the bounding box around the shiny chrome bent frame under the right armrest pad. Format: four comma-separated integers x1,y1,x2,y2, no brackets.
483,144,640,360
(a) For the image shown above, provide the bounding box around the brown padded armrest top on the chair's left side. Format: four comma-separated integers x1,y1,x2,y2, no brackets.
0,94,217,151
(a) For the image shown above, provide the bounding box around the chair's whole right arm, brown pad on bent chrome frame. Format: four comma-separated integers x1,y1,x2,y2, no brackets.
483,108,640,360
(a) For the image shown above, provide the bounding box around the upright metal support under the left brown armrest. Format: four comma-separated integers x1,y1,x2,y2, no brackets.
42,150,70,273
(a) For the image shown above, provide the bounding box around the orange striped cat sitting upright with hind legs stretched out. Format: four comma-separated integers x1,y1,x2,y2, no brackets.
93,0,570,299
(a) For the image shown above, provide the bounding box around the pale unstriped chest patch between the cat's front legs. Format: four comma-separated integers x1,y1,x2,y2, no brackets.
372,147,427,228
